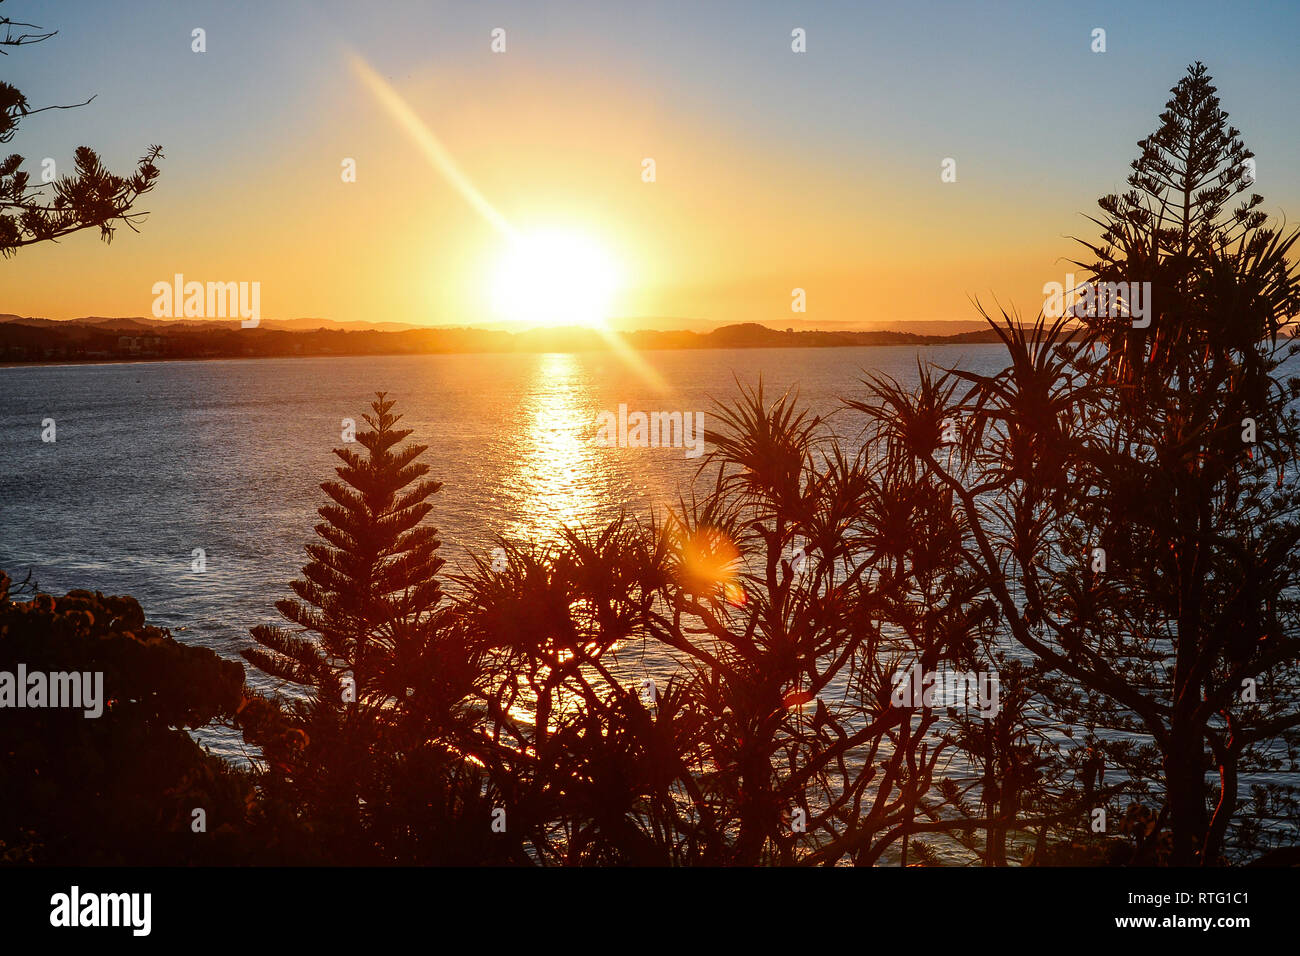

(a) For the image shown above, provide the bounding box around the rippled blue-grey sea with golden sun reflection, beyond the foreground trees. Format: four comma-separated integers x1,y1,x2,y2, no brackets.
0,345,1004,756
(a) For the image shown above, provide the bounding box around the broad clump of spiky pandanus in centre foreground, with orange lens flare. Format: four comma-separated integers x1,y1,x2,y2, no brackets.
455,385,1008,865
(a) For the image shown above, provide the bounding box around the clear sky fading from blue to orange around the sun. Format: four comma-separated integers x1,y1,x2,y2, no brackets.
0,0,1300,328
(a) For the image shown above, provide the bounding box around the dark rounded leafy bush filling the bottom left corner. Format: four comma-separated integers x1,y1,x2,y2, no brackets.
0,572,289,865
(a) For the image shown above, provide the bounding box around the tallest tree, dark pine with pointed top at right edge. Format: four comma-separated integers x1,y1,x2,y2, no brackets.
1076,62,1300,865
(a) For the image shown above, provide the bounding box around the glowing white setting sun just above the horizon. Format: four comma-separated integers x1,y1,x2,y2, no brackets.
490,230,621,328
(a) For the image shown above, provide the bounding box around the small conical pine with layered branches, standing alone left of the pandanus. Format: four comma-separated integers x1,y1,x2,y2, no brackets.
243,393,501,862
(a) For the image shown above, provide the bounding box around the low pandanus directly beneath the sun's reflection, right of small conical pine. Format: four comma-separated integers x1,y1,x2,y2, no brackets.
454,518,720,865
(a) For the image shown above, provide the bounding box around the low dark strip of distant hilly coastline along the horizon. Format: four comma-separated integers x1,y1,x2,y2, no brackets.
0,317,998,368
